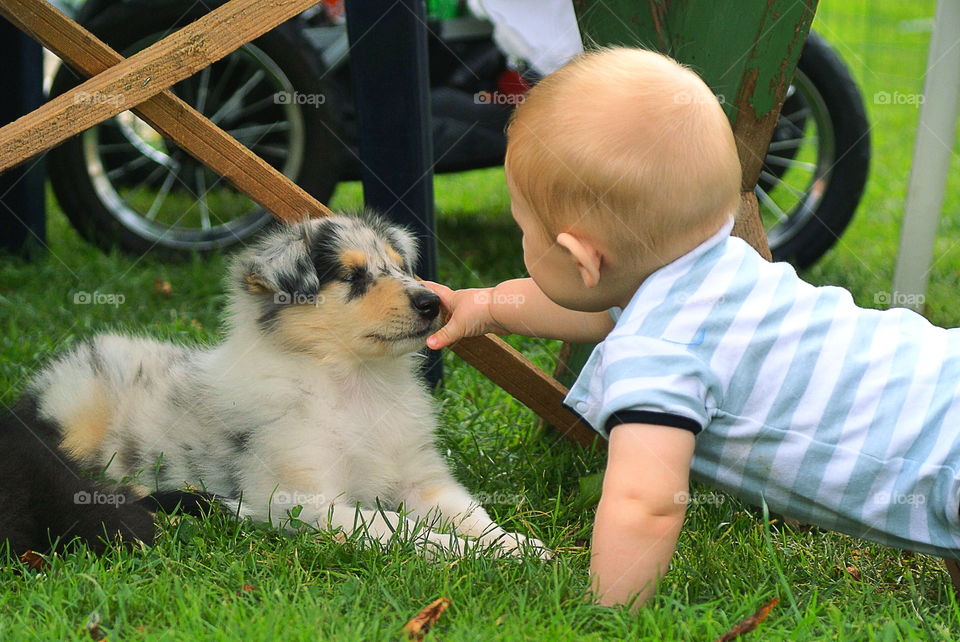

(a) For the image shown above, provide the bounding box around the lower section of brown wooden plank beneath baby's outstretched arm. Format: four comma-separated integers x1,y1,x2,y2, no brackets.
451,334,597,446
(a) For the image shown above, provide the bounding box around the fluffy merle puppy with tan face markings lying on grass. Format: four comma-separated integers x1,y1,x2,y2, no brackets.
29,214,549,557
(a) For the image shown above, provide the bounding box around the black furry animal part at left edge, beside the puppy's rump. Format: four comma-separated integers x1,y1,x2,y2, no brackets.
0,398,155,555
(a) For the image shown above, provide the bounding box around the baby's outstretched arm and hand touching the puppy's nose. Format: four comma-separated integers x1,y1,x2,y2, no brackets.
424,279,613,350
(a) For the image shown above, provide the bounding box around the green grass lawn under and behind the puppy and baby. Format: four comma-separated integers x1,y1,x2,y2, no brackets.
0,0,960,640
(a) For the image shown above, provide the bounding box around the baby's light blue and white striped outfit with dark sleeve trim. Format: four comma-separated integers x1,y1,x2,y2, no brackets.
566,223,960,555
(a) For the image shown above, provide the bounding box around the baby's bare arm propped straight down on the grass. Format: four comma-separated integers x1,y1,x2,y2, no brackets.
590,424,694,607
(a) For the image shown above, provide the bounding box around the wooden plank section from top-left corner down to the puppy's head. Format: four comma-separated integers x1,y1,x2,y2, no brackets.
0,0,332,222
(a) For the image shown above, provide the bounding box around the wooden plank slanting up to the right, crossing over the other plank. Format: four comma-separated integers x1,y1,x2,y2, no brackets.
0,0,316,172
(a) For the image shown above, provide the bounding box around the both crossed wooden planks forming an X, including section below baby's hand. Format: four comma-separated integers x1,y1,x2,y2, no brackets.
0,0,595,444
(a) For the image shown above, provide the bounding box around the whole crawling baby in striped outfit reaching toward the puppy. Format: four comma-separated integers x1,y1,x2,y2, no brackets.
427,48,960,605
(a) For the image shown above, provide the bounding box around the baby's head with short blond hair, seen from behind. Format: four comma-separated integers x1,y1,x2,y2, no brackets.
506,47,741,309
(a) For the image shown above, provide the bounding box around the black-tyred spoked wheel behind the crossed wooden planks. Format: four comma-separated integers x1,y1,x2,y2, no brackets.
48,0,340,255
